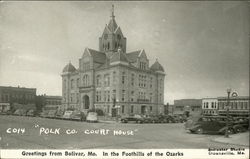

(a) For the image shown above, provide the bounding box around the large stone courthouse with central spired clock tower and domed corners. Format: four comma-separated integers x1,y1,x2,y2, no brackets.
61,5,165,115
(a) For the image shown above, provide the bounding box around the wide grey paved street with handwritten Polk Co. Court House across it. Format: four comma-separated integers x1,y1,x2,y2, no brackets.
0,115,246,149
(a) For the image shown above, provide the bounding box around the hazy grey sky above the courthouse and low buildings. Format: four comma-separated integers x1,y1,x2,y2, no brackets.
0,1,249,104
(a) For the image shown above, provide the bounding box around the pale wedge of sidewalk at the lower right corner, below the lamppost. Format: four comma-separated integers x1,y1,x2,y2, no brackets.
213,131,249,147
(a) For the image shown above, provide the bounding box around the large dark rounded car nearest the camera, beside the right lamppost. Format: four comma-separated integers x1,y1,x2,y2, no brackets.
187,116,235,134
